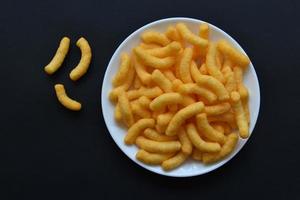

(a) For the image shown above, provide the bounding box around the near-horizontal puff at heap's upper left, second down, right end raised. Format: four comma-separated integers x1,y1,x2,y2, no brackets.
146,42,181,58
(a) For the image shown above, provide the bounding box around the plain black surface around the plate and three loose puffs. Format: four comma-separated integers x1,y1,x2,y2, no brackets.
0,0,300,199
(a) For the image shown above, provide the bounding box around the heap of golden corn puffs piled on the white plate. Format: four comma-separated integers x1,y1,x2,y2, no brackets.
109,23,251,171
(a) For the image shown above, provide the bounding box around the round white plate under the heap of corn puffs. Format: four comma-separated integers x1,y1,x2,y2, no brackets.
101,17,260,177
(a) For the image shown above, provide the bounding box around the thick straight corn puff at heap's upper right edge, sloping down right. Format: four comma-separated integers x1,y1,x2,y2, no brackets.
217,40,250,68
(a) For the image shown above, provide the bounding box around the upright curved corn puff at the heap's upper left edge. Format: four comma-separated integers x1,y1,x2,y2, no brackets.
112,53,130,87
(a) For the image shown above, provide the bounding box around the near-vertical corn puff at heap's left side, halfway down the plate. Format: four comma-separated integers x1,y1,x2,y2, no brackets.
118,91,134,127
